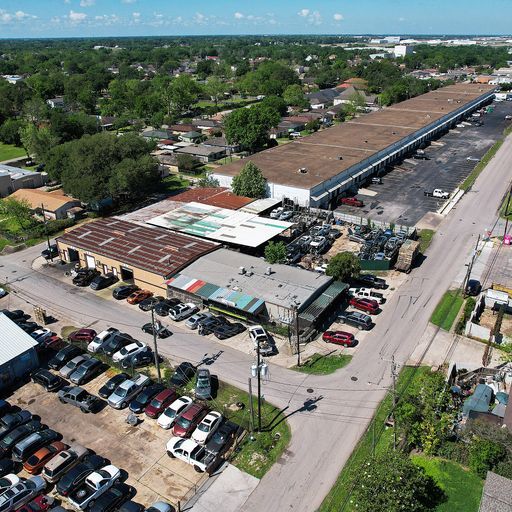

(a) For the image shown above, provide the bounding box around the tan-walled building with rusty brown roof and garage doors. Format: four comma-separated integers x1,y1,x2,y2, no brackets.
56,218,219,295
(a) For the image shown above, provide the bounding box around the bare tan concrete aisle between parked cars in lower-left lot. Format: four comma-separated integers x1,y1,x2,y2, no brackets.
9,373,203,507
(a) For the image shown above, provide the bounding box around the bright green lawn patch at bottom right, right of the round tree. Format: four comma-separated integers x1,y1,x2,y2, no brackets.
411,455,484,512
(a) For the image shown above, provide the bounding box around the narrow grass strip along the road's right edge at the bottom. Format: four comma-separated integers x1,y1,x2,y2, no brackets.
318,366,430,512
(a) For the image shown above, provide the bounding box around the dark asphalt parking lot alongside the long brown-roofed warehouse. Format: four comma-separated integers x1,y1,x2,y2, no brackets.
338,101,512,226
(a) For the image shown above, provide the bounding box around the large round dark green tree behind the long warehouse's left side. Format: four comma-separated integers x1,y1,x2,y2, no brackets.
224,105,280,152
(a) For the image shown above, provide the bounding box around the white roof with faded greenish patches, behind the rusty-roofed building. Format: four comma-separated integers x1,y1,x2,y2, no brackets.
147,202,292,248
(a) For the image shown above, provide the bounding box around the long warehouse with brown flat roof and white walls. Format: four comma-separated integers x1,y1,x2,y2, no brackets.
213,83,495,207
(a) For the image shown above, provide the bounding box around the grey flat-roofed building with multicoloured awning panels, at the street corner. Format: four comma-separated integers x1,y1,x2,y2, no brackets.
167,249,338,325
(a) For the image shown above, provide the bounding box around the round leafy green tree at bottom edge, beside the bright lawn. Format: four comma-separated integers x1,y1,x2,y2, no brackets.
351,451,444,512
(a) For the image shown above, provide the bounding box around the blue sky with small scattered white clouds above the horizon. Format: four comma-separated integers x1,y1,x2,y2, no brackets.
0,0,512,38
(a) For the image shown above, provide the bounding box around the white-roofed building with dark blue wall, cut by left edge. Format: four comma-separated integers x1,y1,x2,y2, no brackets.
0,313,39,391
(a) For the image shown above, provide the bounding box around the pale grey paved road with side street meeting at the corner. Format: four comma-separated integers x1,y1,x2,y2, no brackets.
0,134,512,512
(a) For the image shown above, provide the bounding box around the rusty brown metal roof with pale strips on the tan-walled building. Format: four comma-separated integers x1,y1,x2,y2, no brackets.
57,218,219,277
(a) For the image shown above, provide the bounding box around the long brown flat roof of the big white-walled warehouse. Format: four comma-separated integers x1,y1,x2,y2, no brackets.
215,84,495,189
